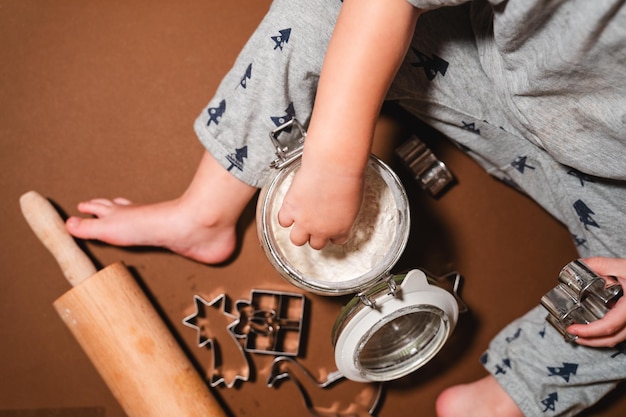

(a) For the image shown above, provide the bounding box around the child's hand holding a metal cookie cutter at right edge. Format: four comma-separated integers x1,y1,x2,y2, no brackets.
567,258,626,347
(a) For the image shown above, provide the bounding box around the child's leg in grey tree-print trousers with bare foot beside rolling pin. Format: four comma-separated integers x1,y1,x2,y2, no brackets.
67,0,341,263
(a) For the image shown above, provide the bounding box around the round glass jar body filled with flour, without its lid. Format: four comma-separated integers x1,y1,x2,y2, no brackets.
257,151,410,295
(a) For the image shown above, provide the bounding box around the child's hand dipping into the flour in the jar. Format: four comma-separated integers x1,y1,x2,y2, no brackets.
278,155,363,249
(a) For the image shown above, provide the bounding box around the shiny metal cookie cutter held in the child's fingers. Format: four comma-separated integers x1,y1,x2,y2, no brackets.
541,259,623,342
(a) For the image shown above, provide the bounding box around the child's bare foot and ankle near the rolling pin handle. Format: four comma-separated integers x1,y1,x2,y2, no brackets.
66,152,256,263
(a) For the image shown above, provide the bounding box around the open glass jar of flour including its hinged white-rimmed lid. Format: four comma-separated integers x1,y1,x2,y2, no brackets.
256,119,459,382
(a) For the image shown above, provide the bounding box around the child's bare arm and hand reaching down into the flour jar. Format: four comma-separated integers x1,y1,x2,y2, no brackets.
279,0,419,249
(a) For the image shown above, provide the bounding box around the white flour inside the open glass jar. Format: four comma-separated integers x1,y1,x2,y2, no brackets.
271,167,398,282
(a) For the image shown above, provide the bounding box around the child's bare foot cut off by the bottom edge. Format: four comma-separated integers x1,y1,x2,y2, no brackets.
437,375,523,417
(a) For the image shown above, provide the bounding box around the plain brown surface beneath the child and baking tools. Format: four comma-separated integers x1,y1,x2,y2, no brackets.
0,0,626,417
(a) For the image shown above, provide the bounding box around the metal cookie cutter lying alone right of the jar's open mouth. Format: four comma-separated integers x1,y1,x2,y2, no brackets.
396,135,454,197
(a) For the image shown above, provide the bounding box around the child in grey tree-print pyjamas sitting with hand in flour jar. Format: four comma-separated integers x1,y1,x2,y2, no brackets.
67,0,626,416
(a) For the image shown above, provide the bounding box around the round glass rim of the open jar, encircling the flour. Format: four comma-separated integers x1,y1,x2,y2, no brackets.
256,155,410,296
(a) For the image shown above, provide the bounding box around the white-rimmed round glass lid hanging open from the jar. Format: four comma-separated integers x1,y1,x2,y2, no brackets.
332,269,459,382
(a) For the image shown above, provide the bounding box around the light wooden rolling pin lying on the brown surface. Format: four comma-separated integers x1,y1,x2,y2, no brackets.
20,191,226,417
